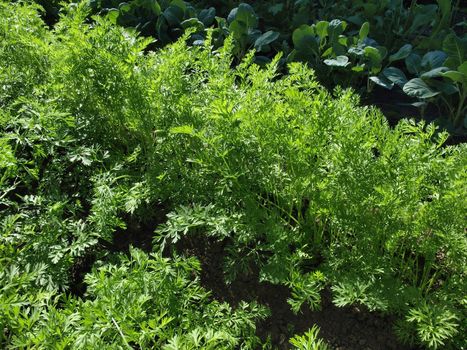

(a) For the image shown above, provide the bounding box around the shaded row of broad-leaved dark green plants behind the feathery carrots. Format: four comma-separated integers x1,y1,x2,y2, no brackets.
39,0,467,135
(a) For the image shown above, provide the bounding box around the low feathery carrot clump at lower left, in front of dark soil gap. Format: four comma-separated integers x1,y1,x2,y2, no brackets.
2,250,265,349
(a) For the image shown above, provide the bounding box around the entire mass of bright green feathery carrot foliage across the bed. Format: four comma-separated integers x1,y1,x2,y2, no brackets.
0,2,467,349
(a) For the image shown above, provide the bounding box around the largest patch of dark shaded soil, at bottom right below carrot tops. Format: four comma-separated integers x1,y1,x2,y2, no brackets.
178,237,415,350
